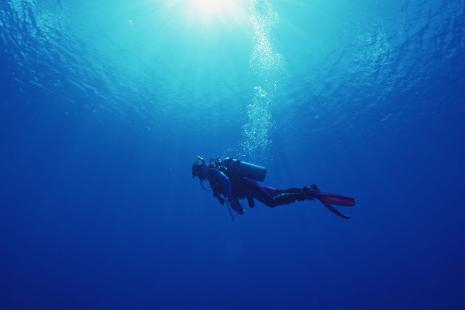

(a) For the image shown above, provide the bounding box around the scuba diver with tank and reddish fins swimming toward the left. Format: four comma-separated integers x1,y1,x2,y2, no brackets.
192,156,355,219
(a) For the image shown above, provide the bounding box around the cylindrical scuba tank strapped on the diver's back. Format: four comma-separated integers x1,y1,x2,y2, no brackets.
214,157,266,182
